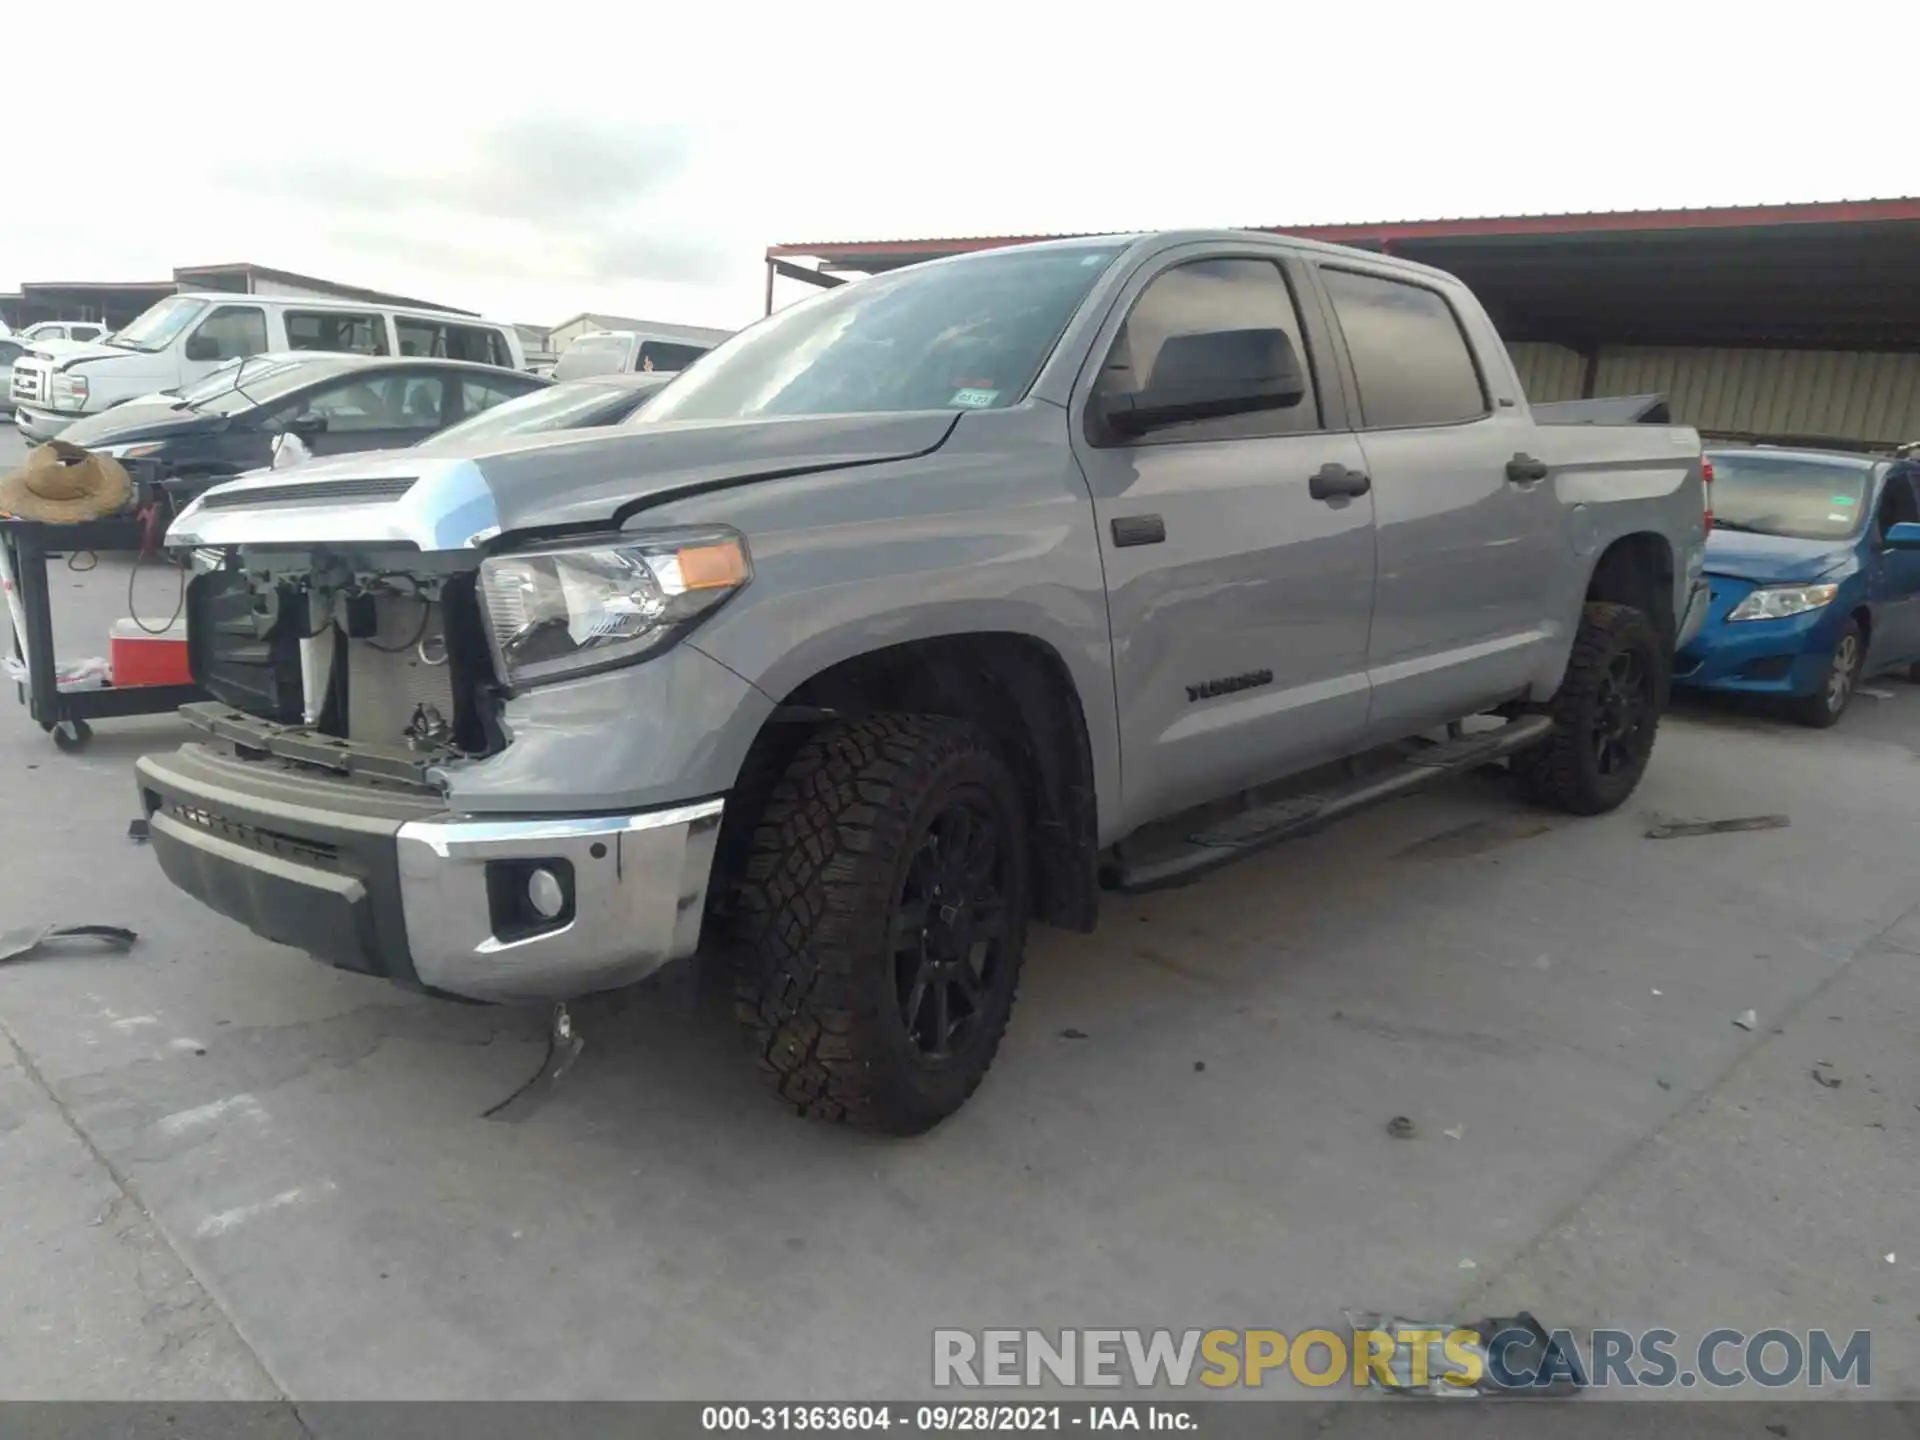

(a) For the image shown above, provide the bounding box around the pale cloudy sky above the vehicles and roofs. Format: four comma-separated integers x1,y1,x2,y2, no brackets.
0,0,1920,324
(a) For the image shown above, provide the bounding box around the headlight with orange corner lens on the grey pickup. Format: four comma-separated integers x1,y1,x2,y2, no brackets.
480,528,753,689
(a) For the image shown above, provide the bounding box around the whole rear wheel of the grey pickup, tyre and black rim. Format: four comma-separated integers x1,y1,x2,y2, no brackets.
1513,601,1667,814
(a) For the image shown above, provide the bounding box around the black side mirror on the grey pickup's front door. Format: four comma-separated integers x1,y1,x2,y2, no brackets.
1100,330,1308,436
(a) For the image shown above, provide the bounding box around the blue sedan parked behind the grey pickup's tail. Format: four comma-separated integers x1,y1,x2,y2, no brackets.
1674,447,1920,728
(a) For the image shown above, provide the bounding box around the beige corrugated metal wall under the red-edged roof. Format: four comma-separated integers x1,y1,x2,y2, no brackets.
1507,342,1920,444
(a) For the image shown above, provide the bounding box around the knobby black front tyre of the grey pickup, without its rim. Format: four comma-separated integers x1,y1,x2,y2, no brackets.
733,714,1029,1135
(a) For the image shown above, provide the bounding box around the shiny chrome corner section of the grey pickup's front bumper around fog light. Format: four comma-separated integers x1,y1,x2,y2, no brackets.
397,801,722,1000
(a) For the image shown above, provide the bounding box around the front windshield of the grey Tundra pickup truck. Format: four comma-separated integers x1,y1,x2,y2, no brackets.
639,244,1123,424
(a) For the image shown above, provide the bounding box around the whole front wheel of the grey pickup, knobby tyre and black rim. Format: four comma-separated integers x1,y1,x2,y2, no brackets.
733,714,1027,1135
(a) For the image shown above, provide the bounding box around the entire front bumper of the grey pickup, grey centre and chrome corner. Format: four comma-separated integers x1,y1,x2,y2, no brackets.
134,745,722,1000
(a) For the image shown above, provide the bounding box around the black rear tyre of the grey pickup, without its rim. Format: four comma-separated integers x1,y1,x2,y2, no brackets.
1513,601,1668,814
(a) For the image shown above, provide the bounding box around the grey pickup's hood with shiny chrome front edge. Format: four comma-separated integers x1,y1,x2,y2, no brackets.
167,411,960,551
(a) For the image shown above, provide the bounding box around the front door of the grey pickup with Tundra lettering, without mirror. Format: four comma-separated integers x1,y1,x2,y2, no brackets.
1071,246,1373,826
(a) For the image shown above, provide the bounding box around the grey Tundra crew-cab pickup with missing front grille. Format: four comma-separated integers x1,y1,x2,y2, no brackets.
138,232,1705,1133
